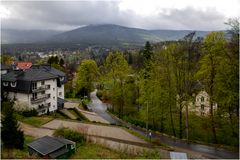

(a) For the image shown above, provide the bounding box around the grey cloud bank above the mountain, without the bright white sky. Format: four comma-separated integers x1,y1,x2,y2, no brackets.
2,1,230,30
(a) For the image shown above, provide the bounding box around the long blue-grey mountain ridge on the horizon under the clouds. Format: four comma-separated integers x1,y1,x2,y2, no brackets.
2,24,210,46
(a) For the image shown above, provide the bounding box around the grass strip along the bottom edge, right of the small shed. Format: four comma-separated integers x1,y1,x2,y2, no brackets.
70,143,160,159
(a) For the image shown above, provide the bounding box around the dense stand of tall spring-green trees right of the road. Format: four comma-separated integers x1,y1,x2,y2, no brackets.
66,20,239,147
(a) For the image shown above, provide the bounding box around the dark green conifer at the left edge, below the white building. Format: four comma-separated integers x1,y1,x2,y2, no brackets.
1,100,24,149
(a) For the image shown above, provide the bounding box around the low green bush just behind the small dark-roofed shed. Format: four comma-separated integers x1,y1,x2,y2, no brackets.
54,128,86,145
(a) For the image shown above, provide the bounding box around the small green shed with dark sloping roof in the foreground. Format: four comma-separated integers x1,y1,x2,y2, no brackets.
27,136,76,159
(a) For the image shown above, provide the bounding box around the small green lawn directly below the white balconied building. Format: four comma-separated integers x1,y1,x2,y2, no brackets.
17,115,54,127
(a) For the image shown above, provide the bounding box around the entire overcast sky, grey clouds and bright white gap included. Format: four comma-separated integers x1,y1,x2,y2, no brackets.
0,0,240,30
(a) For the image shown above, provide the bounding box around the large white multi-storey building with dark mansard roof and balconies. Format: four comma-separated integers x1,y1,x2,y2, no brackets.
1,65,66,114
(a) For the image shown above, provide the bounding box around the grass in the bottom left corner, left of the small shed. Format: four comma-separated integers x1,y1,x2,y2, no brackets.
1,135,34,159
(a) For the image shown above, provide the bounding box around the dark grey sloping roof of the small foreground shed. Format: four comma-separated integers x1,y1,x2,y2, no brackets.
28,136,74,156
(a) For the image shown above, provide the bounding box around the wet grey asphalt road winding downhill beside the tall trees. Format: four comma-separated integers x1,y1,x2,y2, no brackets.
91,90,239,159
